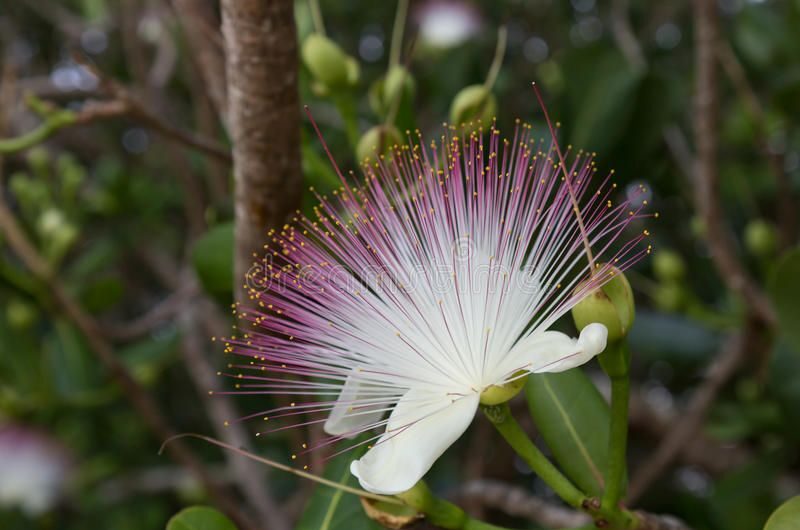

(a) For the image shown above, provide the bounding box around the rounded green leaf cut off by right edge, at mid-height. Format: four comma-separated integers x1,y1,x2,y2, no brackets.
769,248,800,351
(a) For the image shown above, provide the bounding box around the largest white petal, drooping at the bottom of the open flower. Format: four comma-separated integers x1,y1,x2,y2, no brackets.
350,389,479,495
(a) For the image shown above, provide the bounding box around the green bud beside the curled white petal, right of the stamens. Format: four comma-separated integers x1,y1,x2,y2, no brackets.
572,267,636,344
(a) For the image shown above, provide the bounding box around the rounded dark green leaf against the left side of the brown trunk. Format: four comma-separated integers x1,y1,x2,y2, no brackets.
192,223,233,297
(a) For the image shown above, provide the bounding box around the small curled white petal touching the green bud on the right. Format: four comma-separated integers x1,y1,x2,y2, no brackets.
512,323,608,373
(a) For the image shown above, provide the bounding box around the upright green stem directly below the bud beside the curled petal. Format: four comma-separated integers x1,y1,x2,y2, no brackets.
602,373,630,509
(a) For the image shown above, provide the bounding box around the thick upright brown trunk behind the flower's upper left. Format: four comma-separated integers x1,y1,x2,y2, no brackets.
222,0,302,300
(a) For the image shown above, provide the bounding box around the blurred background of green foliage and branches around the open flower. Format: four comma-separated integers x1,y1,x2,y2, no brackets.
0,0,800,530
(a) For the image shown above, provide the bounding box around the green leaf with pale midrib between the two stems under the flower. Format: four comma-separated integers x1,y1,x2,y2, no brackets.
525,368,610,495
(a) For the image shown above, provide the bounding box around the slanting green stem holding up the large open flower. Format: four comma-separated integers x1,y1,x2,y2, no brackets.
482,403,586,509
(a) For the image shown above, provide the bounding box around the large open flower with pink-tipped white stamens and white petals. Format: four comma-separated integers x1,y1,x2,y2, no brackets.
220,118,649,494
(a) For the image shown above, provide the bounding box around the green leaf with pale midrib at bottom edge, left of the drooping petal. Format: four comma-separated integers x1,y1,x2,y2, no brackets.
295,440,381,530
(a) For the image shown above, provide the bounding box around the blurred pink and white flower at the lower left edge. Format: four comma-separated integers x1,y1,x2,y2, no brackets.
0,424,71,516
